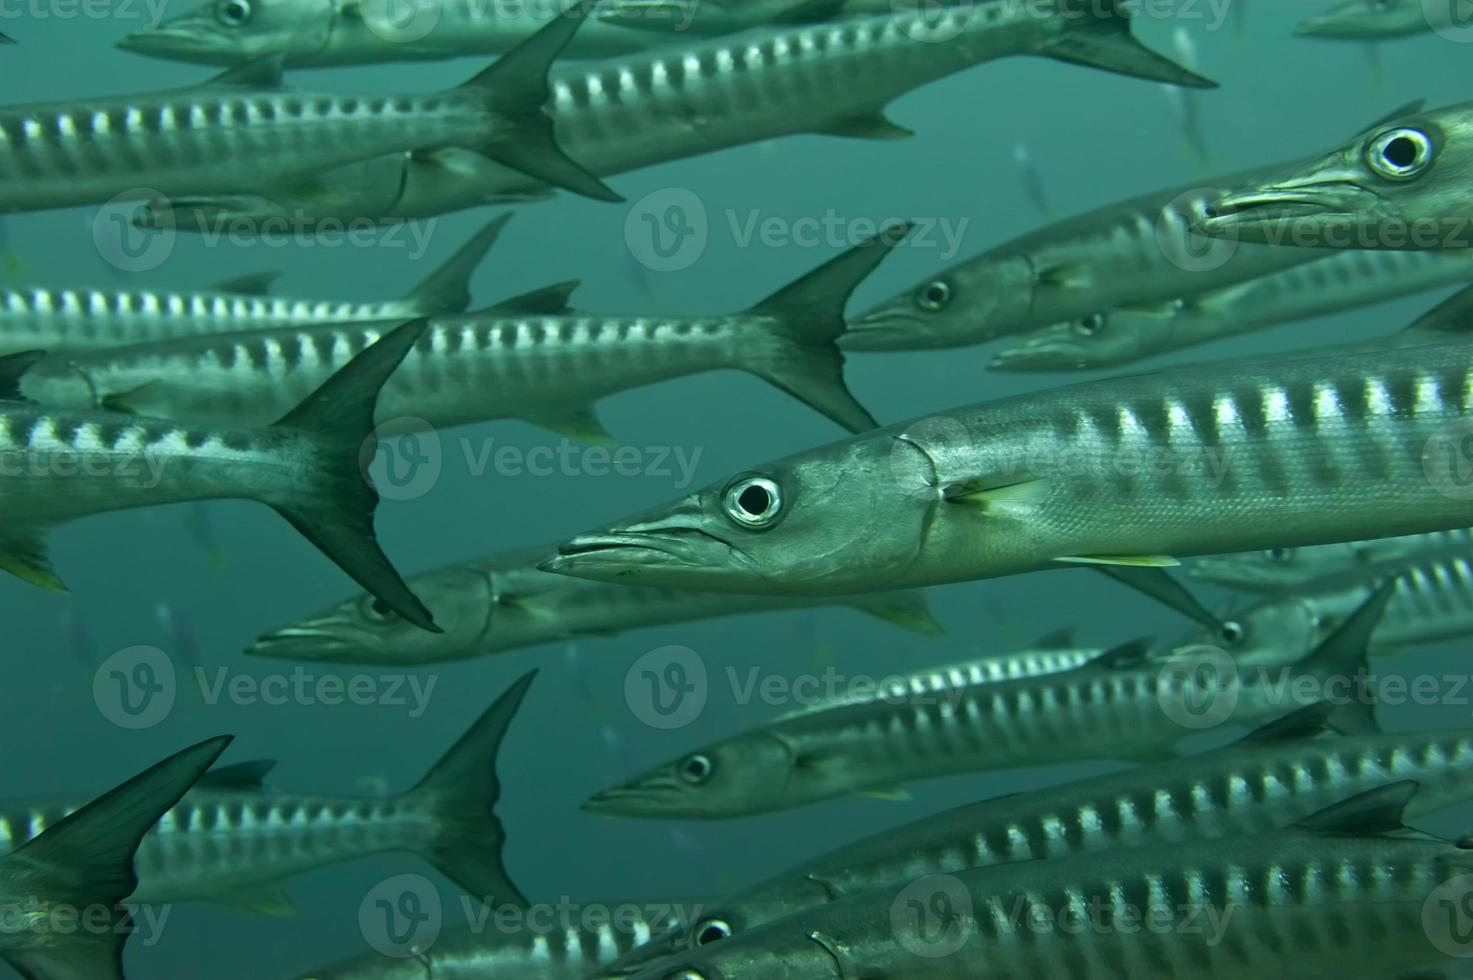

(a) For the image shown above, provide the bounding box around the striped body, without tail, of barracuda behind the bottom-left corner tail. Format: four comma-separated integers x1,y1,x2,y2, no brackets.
0,790,437,908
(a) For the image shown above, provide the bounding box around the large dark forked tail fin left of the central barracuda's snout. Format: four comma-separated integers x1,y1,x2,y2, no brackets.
267,320,440,632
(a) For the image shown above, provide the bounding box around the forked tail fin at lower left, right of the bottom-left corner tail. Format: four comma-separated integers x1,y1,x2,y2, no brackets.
409,671,538,906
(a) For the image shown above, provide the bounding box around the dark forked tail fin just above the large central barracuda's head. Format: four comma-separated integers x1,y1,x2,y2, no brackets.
742,224,910,432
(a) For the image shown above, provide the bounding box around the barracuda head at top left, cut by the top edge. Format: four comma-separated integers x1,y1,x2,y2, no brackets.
118,0,339,65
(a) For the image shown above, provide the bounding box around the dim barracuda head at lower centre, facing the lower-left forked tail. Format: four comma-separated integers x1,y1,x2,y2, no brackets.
583,728,804,819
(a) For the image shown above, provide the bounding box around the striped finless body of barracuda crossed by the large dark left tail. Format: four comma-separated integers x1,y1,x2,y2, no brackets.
22,315,785,429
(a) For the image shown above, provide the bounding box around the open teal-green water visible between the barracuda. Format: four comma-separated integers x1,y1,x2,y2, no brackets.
0,0,1473,980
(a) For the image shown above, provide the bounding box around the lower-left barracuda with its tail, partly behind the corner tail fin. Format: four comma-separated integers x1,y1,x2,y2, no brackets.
0,671,536,915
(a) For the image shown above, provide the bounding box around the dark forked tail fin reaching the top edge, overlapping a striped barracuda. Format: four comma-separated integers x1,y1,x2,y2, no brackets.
457,3,623,200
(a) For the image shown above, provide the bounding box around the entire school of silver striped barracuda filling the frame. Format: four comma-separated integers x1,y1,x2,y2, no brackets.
0,0,1473,980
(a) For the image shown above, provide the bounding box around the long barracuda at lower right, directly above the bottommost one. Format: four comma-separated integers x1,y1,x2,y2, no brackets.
601,703,1473,977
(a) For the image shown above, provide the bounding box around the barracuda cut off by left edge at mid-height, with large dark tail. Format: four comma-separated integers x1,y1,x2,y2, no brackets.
0,320,435,629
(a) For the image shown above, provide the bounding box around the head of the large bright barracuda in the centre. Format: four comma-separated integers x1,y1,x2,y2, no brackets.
539,430,934,595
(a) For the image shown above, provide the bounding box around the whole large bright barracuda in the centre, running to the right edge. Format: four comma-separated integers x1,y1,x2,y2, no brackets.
541,342,1473,595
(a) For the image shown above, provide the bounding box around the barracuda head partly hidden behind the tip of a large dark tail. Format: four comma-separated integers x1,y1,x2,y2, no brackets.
246,566,494,666
